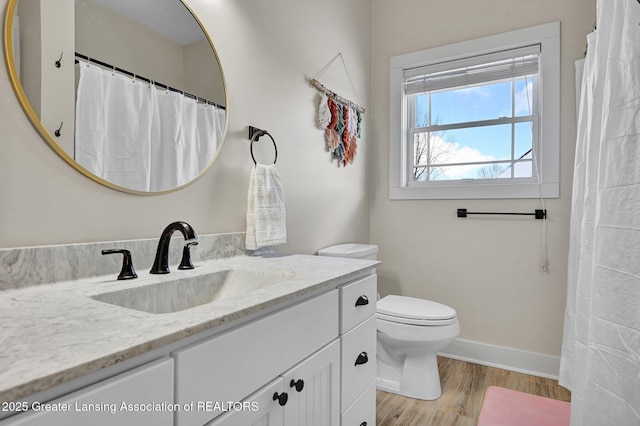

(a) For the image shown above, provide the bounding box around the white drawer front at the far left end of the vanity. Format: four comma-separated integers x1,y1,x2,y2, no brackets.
0,358,173,426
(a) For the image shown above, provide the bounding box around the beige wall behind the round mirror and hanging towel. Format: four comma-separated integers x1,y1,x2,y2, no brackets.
0,0,371,253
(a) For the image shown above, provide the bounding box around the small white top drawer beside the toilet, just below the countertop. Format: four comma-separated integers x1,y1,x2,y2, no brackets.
340,275,378,334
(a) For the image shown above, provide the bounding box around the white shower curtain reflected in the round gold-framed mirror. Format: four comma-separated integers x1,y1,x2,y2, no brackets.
75,63,219,192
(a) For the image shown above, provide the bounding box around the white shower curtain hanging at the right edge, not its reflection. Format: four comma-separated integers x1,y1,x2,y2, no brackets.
560,0,640,426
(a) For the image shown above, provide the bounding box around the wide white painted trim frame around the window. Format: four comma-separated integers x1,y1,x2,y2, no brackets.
389,22,560,200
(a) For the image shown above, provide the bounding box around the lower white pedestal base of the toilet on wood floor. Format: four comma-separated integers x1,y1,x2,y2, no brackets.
376,352,442,401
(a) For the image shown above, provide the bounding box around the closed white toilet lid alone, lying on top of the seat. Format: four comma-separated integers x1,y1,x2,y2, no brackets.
377,295,456,320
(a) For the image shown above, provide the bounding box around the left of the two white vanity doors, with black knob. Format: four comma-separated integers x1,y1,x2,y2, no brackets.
207,377,288,426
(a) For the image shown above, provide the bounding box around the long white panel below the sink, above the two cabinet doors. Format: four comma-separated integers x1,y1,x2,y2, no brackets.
172,290,338,426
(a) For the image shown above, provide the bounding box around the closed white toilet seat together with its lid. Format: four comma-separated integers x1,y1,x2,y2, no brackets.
377,295,458,326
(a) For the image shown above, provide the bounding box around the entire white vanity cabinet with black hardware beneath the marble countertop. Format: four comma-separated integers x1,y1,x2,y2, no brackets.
0,275,377,426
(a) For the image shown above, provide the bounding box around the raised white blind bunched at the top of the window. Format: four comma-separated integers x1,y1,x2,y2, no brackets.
404,44,540,95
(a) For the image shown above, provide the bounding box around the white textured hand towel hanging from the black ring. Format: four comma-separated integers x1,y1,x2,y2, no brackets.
245,164,287,250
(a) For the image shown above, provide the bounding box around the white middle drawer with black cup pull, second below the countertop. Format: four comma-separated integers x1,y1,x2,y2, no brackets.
340,316,377,411
